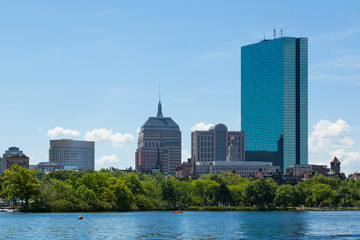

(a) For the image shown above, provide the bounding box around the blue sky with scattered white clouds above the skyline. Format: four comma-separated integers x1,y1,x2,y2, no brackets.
0,0,360,174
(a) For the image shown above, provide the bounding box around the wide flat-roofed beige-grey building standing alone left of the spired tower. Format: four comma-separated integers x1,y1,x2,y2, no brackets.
49,139,95,170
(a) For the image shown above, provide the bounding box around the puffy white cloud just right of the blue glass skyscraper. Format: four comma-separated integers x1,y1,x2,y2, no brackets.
309,119,354,152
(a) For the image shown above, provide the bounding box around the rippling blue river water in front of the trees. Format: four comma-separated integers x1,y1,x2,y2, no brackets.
0,211,360,240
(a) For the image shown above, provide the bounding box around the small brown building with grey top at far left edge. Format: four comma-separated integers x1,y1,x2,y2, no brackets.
1,147,29,172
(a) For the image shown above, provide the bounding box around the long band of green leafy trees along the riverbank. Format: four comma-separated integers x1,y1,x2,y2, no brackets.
0,165,360,212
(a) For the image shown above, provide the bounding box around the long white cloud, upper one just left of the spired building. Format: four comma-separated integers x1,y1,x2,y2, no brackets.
85,128,135,147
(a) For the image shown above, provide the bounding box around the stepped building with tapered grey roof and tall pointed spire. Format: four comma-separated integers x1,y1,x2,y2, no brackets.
135,101,181,176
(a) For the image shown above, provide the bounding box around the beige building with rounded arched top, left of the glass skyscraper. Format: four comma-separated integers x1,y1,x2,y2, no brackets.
191,124,245,163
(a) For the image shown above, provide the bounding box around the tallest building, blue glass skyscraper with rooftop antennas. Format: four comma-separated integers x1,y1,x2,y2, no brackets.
241,37,308,170
